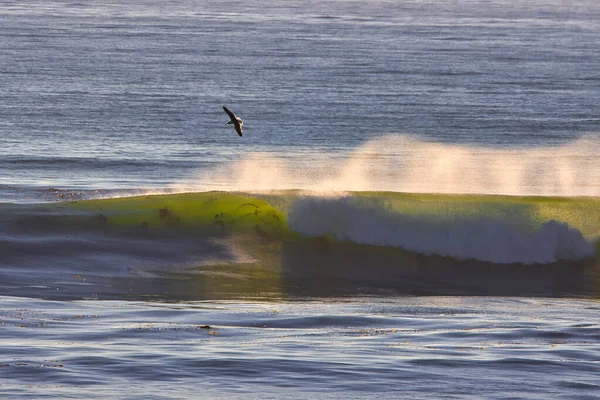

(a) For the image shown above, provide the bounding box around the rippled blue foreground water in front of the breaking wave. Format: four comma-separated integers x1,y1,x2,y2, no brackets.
0,297,600,399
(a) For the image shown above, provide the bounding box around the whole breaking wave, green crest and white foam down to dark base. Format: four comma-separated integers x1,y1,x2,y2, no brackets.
0,191,600,300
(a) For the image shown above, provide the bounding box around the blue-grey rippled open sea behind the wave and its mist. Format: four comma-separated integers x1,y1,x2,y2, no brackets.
0,0,600,197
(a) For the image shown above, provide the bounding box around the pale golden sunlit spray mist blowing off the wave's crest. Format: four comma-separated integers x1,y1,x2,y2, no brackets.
173,134,600,196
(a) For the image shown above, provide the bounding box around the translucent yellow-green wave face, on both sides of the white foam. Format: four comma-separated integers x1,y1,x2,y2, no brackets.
55,191,600,239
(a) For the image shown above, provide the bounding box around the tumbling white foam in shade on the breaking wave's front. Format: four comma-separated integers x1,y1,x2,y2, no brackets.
288,197,594,264
